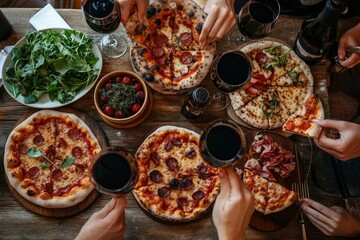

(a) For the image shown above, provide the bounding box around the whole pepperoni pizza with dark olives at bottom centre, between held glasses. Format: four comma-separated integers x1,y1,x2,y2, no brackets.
133,126,220,222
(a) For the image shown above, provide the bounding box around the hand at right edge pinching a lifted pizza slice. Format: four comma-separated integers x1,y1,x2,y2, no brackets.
313,119,360,160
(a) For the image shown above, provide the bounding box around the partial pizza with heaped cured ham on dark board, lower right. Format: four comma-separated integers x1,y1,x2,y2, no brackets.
243,134,297,215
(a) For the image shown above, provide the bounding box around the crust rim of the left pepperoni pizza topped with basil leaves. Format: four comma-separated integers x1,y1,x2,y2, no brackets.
4,110,101,208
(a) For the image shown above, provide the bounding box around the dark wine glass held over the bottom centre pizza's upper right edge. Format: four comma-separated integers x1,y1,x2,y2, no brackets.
200,119,246,167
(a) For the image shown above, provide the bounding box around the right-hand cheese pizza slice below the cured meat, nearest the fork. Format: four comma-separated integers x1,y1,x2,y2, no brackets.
264,182,297,215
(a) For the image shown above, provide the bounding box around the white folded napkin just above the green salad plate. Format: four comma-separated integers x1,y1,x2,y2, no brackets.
29,4,71,31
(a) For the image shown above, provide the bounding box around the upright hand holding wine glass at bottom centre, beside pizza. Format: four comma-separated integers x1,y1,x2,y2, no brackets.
212,167,255,240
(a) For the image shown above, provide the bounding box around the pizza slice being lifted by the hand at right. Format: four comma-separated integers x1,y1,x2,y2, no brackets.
282,94,325,138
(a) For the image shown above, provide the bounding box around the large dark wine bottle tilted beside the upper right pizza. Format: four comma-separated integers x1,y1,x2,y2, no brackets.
294,0,348,64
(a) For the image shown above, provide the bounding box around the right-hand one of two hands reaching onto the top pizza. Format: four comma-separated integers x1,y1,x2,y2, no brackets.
199,0,236,47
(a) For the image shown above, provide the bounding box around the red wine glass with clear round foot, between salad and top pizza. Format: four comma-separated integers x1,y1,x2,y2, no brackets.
81,0,127,58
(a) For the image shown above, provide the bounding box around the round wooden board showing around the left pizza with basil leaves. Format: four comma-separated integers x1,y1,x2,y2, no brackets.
4,108,108,217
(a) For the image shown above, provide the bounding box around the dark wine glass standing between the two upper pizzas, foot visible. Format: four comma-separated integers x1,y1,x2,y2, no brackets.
210,50,252,110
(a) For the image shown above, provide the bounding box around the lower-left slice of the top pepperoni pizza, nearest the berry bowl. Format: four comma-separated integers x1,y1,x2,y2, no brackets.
130,43,173,94
